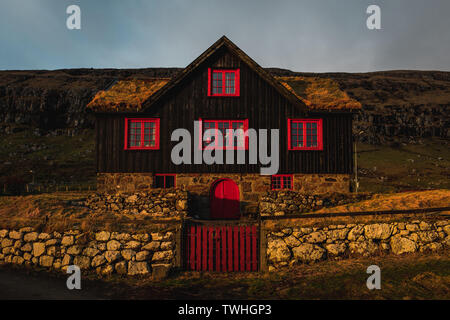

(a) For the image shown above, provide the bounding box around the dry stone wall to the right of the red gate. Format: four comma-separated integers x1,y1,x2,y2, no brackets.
266,220,450,270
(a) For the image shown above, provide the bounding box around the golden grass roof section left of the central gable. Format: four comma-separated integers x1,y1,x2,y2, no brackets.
87,78,170,112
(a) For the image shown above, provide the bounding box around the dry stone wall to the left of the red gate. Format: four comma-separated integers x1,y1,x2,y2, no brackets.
0,228,177,278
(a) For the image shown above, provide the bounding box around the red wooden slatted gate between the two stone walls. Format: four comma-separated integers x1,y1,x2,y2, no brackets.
185,225,259,271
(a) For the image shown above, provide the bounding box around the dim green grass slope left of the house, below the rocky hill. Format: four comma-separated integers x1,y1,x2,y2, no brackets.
0,126,95,185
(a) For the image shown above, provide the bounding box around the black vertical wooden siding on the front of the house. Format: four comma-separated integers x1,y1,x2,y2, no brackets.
96,49,352,174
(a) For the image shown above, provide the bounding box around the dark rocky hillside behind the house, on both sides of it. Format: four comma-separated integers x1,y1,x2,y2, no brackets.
0,68,450,144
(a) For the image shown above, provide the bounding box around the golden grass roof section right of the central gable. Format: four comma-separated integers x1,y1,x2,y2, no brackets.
276,76,361,110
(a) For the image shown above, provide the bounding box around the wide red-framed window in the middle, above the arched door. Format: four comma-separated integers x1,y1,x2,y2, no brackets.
199,119,248,150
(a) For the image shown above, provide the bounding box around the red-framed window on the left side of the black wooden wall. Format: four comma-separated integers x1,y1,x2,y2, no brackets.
125,118,159,150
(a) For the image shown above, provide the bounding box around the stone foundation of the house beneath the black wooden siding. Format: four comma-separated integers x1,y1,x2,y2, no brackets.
97,173,350,218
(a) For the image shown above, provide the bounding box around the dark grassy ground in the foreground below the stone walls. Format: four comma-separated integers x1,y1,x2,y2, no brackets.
0,251,450,300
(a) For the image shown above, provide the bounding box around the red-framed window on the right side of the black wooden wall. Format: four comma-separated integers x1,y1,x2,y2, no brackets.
288,119,323,150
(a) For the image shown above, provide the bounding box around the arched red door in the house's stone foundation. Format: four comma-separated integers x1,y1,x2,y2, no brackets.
211,179,240,219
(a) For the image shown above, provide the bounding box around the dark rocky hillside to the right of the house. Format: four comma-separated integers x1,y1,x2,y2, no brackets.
270,69,450,144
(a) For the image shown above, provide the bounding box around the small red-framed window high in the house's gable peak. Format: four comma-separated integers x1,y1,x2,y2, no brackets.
208,68,240,97
